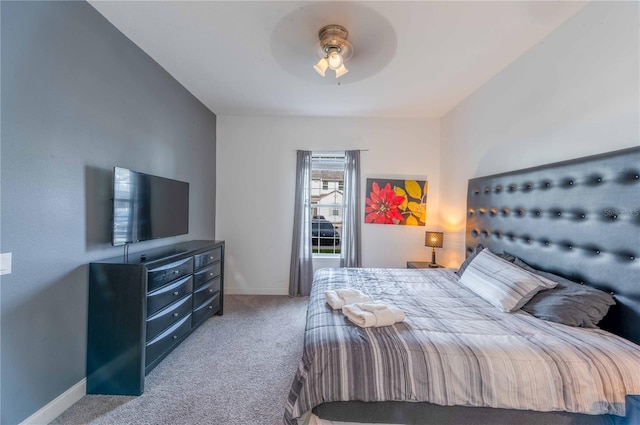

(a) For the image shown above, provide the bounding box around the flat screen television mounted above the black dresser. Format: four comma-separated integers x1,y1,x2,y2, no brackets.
111,167,189,246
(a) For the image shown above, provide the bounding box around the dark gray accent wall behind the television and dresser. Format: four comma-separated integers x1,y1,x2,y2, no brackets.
0,1,216,424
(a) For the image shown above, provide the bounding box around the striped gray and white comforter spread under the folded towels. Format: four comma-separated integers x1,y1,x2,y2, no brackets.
284,269,640,424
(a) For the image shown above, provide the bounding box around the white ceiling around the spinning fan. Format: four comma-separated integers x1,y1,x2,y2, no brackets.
90,0,585,117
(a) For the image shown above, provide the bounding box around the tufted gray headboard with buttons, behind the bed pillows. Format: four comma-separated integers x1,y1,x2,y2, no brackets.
466,147,640,344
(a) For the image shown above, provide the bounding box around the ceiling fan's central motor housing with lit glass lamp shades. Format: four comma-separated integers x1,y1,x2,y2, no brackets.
313,24,353,78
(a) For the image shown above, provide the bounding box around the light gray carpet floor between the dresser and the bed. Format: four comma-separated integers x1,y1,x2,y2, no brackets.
52,295,308,425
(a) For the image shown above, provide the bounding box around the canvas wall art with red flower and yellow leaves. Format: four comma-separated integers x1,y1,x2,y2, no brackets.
364,178,427,226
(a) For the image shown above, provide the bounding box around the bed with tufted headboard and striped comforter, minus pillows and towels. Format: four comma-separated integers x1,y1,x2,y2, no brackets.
285,148,640,424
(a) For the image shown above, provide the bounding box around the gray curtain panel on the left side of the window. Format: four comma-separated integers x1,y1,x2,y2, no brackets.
289,151,313,297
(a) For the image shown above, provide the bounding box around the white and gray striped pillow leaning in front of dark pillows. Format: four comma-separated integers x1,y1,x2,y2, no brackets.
460,248,557,312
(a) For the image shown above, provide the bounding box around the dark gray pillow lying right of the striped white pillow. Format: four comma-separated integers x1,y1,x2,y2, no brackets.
514,258,616,328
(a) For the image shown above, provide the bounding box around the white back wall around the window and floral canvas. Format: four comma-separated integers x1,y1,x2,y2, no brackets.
216,116,440,294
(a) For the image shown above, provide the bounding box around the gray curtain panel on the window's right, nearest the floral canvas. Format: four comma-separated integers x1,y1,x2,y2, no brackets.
340,150,362,267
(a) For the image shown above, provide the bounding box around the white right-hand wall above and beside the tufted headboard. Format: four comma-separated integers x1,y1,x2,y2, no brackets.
440,2,640,266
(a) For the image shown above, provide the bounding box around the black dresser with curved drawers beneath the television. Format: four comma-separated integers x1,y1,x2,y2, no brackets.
87,240,224,395
